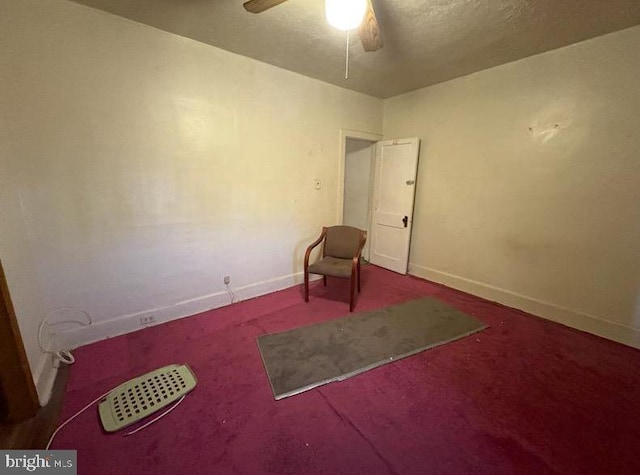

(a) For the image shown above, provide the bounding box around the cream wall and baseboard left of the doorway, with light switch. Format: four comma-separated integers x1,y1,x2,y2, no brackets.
0,0,382,402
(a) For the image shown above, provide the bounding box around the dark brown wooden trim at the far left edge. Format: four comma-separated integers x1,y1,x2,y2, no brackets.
0,261,40,422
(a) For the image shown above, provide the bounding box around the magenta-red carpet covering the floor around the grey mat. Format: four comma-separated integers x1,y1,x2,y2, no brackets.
53,266,640,475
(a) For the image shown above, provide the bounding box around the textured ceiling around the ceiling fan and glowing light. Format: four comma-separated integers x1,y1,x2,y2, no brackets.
74,0,640,97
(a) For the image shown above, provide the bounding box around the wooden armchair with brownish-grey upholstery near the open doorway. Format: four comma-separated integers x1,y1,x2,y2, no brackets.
304,226,367,312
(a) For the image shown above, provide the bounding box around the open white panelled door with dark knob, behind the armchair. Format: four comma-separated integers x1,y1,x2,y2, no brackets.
370,138,420,274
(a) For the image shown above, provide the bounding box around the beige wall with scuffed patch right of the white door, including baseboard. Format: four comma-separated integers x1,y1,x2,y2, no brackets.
384,27,640,345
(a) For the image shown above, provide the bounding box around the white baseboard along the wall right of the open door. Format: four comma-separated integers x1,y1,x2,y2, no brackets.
409,263,640,349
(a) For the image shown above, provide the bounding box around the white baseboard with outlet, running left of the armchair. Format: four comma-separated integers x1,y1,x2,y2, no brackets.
59,272,317,348
